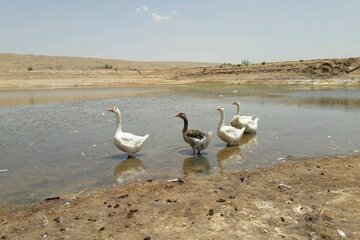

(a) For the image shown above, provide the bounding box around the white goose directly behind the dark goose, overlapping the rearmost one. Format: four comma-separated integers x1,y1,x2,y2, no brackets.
217,106,245,146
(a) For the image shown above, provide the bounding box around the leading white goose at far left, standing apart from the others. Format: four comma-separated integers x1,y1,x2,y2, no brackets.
108,107,149,157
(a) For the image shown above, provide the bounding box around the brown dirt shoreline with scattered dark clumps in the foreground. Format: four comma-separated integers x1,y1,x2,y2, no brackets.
0,155,360,239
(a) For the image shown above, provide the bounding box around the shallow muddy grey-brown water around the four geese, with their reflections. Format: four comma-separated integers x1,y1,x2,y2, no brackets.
0,85,360,203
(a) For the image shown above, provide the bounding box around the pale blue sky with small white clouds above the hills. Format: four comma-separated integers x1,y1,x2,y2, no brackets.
0,0,360,63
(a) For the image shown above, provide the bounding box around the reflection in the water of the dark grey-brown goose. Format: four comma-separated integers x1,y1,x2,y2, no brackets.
183,155,211,176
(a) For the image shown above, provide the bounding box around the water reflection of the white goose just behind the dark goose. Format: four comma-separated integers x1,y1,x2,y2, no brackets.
216,146,244,175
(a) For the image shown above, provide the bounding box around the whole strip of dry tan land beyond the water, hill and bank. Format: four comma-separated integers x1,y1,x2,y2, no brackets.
0,54,360,89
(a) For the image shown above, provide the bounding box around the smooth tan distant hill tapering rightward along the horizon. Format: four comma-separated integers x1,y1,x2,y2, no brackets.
0,53,219,70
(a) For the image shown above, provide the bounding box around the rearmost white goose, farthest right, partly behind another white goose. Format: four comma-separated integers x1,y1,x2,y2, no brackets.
231,101,259,133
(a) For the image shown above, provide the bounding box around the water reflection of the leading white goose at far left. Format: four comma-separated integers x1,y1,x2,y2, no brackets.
114,157,146,183
